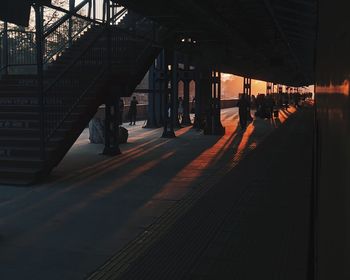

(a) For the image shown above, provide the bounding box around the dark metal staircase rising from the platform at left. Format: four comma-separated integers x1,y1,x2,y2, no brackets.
0,2,165,184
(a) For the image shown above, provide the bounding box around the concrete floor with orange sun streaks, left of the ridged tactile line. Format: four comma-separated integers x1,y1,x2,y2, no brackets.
0,108,304,280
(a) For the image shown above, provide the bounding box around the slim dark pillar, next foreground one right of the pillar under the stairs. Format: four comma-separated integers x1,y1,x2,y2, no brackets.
162,50,178,138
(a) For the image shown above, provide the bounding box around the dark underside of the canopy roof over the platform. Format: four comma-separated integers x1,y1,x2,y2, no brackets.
118,0,317,86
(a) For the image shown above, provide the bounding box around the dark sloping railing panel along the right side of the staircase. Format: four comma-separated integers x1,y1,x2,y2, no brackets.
44,26,108,143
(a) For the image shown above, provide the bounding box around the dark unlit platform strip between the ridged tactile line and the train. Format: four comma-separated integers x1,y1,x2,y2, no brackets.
89,106,312,280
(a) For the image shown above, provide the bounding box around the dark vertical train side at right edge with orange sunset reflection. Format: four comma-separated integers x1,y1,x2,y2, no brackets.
315,0,350,280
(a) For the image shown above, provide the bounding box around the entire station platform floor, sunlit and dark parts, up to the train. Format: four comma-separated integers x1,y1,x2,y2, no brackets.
0,107,313,280
